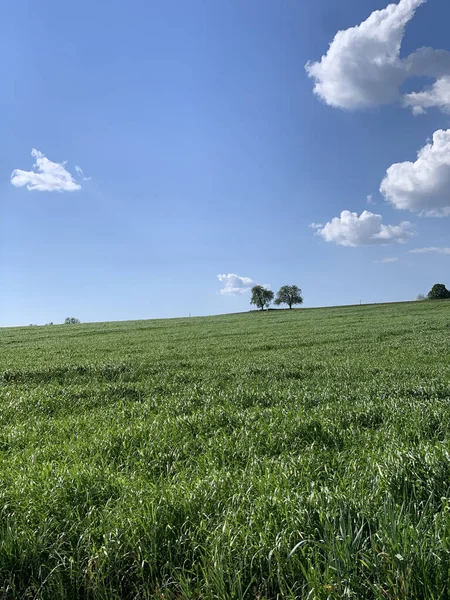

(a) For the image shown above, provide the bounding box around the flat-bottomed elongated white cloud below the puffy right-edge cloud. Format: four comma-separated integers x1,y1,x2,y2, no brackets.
316,210,415,246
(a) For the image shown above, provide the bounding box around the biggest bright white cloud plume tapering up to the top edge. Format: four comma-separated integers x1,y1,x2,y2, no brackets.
306,0,425,109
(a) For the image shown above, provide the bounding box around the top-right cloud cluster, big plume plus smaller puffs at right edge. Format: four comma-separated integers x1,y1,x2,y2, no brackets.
306,0,450,114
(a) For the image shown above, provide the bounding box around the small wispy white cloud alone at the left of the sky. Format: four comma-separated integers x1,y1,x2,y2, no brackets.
11,148,81,192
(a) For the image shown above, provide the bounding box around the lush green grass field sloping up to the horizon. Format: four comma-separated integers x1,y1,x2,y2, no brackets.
0,302,450,600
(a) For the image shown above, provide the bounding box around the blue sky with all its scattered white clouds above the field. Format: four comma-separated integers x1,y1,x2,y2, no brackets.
0,0,450,326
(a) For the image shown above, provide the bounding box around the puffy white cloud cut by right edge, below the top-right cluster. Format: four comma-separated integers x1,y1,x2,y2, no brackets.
380,129,450,216
